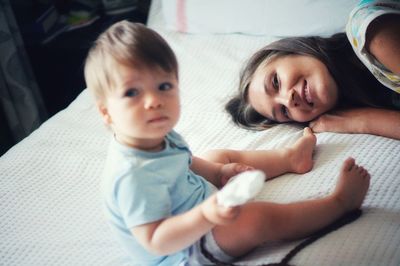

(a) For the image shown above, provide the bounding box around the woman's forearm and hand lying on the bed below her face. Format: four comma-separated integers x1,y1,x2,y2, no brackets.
310,107,400,140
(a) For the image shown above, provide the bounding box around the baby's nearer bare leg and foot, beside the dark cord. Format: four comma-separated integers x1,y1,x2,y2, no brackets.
213,158,370,257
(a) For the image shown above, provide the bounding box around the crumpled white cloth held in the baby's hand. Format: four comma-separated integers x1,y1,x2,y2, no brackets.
217,170,265,207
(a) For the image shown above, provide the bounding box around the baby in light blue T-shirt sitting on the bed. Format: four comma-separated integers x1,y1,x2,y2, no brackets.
85,21,370,266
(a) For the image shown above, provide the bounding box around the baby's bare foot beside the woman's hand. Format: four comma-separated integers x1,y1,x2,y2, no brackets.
288,127,317,174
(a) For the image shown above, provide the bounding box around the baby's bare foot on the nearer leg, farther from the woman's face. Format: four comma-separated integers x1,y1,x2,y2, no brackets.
333,158,371,212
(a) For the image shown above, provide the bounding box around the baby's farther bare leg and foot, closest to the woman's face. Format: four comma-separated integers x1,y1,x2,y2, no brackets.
202,128,317,178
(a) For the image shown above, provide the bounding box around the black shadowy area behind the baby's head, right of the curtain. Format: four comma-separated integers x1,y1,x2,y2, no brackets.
13,0,149,116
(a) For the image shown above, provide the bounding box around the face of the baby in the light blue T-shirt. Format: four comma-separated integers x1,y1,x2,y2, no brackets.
100,63,180,150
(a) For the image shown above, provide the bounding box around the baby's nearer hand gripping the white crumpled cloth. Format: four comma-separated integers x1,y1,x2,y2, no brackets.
201,193,240,225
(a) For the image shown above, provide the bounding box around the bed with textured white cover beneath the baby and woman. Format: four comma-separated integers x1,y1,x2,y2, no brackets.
0,0,400,265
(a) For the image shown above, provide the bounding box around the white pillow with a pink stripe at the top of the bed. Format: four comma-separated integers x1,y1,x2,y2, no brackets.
162,0,359,37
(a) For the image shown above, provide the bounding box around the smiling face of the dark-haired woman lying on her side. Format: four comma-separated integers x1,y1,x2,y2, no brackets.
248,55,338,122
